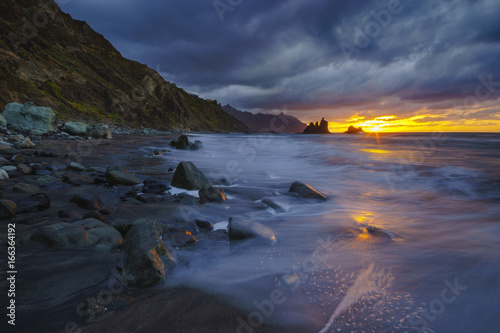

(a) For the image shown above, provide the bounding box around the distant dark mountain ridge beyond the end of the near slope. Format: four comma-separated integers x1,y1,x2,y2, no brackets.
222,104,306,133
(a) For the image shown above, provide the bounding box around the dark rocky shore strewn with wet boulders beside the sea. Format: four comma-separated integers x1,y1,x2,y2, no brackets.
0,105,326,332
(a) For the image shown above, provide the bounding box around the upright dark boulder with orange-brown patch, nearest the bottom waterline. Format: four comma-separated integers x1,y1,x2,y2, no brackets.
123,221,176,287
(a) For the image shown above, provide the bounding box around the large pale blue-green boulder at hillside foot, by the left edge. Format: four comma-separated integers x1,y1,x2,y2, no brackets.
2,102,57,133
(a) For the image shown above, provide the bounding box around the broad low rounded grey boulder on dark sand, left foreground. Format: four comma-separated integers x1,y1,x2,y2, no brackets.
31,219,123,252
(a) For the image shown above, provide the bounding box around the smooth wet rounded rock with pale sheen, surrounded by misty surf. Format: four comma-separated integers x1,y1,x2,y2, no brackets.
228,217,276,244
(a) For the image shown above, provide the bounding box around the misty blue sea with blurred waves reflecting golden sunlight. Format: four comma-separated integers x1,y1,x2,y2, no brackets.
154,133,500,333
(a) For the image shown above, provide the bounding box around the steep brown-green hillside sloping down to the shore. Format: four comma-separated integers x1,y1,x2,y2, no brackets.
0,0,248,131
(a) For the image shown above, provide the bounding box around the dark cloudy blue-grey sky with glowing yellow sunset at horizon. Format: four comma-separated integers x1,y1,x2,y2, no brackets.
57,0,500,132
